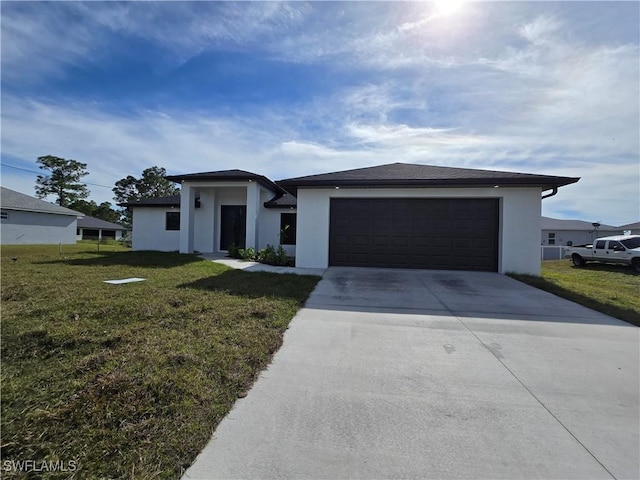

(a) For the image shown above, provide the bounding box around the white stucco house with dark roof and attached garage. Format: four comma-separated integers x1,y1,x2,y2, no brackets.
126,163,579,274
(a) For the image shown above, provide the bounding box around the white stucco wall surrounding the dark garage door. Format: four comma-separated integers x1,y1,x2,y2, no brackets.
296,188,542,275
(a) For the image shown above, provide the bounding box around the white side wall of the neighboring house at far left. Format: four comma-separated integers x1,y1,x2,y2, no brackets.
0,208,78,245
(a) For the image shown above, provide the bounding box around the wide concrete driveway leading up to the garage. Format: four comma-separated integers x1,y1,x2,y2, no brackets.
184,268,640,479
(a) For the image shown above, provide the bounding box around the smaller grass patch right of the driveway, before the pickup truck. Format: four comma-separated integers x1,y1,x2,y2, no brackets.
510,260,640,326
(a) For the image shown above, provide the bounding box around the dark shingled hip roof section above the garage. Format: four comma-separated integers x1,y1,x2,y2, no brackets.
278,163,580,191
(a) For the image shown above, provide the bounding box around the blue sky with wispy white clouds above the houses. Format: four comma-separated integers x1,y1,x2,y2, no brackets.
0,0,640,225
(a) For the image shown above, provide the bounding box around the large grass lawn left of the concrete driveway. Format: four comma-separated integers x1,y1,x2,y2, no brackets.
1,244,318,478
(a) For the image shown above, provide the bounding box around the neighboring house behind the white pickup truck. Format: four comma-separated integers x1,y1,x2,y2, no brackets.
541,217,623,246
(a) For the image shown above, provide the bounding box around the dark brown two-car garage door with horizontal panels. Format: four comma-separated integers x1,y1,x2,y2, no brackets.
329,198,498,271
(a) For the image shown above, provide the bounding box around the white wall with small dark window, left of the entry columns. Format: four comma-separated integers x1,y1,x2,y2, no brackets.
131,207,180,252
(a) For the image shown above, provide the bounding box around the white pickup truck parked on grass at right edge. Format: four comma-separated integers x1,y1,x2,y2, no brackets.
564,235,640,273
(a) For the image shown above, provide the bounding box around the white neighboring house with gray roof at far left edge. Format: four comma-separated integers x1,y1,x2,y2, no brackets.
0,187,83,245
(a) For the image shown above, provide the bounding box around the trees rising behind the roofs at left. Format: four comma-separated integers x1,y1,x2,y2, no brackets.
36,155,180,227
